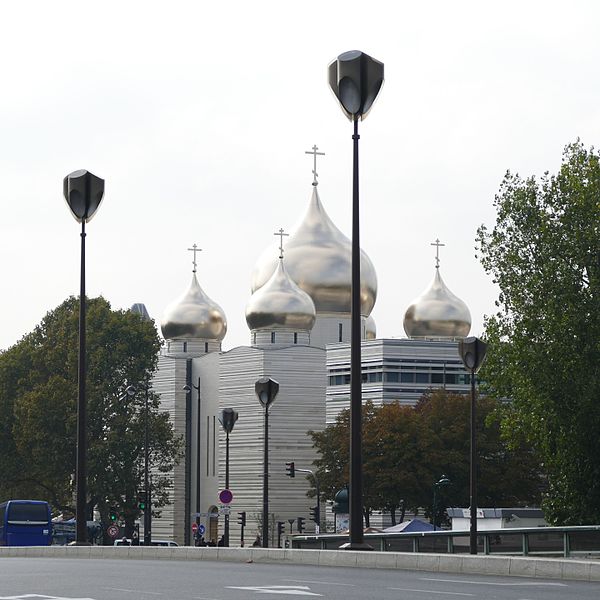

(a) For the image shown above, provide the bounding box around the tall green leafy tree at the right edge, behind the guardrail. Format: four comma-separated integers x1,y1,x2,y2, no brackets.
477,141,600,525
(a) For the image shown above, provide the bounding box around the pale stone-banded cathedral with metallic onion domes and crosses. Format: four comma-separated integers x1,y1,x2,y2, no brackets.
144,147,470,546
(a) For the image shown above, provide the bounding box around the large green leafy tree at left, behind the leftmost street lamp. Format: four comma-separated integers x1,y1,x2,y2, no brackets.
0,297,181,531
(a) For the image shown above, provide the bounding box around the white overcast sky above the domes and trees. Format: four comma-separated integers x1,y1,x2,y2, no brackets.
0,0,600,349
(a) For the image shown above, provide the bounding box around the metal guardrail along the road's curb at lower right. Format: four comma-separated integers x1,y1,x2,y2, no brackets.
290,525,600,557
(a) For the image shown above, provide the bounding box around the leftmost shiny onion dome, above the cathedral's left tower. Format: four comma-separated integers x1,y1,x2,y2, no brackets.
160,272,227,342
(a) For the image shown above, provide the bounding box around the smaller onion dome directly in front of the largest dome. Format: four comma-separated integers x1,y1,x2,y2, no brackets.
246,258,316,331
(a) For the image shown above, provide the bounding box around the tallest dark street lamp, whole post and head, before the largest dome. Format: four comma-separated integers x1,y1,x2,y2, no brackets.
329,50,383,550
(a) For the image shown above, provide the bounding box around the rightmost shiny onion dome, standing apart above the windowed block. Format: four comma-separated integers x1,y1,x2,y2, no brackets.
404,267,471,337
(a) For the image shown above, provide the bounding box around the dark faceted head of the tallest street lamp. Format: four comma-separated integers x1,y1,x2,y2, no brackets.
328,50,383,121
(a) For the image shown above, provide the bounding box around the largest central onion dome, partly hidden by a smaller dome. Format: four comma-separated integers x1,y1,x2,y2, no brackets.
252,185,377,316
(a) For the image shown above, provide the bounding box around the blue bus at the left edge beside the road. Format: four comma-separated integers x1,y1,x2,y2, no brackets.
0,500,52,546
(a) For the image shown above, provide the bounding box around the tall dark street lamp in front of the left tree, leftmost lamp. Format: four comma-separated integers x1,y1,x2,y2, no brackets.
63,170,104,546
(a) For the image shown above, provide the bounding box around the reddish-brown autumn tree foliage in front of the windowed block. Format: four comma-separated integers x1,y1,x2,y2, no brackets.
310,390,542,524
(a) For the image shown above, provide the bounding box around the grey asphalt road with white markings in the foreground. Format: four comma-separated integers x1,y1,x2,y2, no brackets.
0,558,600,600
